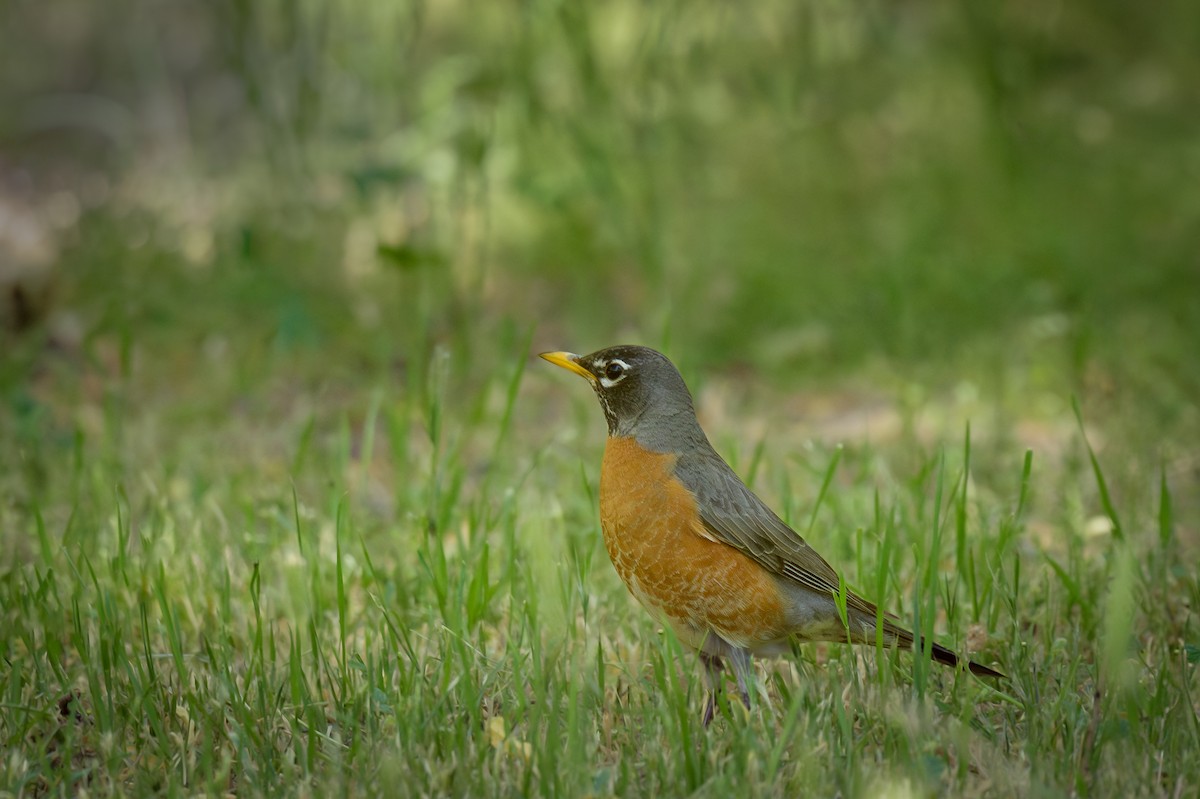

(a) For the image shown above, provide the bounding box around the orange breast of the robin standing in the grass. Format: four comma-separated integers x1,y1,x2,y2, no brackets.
600,438,787,648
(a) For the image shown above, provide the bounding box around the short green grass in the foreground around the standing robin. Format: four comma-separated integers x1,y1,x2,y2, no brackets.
0,321,1200,795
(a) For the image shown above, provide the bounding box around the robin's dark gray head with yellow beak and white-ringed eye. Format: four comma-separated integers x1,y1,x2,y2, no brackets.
541,344,707,452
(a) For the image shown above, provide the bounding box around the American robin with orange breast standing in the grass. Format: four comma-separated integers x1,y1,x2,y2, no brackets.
541,346,1003,725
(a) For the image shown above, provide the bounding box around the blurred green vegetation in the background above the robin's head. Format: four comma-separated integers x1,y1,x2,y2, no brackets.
0,0,1200,484
